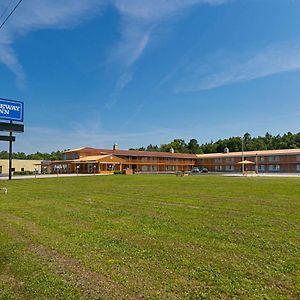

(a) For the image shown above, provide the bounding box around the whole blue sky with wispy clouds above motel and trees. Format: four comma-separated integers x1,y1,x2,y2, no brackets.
0,0,300,152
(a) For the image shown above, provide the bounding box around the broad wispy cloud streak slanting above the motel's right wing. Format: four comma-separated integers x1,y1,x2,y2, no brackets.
175,42,300,92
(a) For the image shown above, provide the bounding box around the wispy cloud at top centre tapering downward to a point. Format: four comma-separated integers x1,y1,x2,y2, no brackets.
108,0,228,106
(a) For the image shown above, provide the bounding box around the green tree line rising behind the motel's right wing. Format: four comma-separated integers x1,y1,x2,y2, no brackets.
131,132,300,154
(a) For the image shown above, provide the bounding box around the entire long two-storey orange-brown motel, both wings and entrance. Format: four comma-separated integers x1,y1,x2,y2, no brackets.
41,145,300,174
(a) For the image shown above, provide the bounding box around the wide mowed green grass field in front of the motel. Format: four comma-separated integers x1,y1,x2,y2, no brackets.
0,175,300,299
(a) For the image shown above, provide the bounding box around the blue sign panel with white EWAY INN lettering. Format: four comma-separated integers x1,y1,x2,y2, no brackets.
0,98,24,122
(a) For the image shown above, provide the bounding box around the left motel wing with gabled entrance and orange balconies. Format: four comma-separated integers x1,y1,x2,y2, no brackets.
42,145,197,174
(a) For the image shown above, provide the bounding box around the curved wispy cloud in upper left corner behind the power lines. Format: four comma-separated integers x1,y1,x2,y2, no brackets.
0,0,106,83
